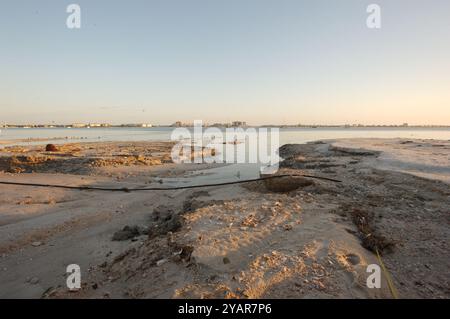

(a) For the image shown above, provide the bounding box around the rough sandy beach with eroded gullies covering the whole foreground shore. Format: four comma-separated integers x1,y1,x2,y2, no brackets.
0,139,450,298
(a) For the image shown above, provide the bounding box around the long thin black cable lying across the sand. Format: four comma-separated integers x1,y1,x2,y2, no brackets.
0,174,342,192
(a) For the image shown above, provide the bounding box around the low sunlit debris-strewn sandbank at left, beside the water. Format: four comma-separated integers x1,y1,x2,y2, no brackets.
0,142,178,175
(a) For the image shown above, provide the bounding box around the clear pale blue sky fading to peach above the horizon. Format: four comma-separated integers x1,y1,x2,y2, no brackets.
0,0,450,125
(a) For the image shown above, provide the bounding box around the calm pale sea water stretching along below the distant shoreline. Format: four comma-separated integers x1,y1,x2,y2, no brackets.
0,127,450,145
